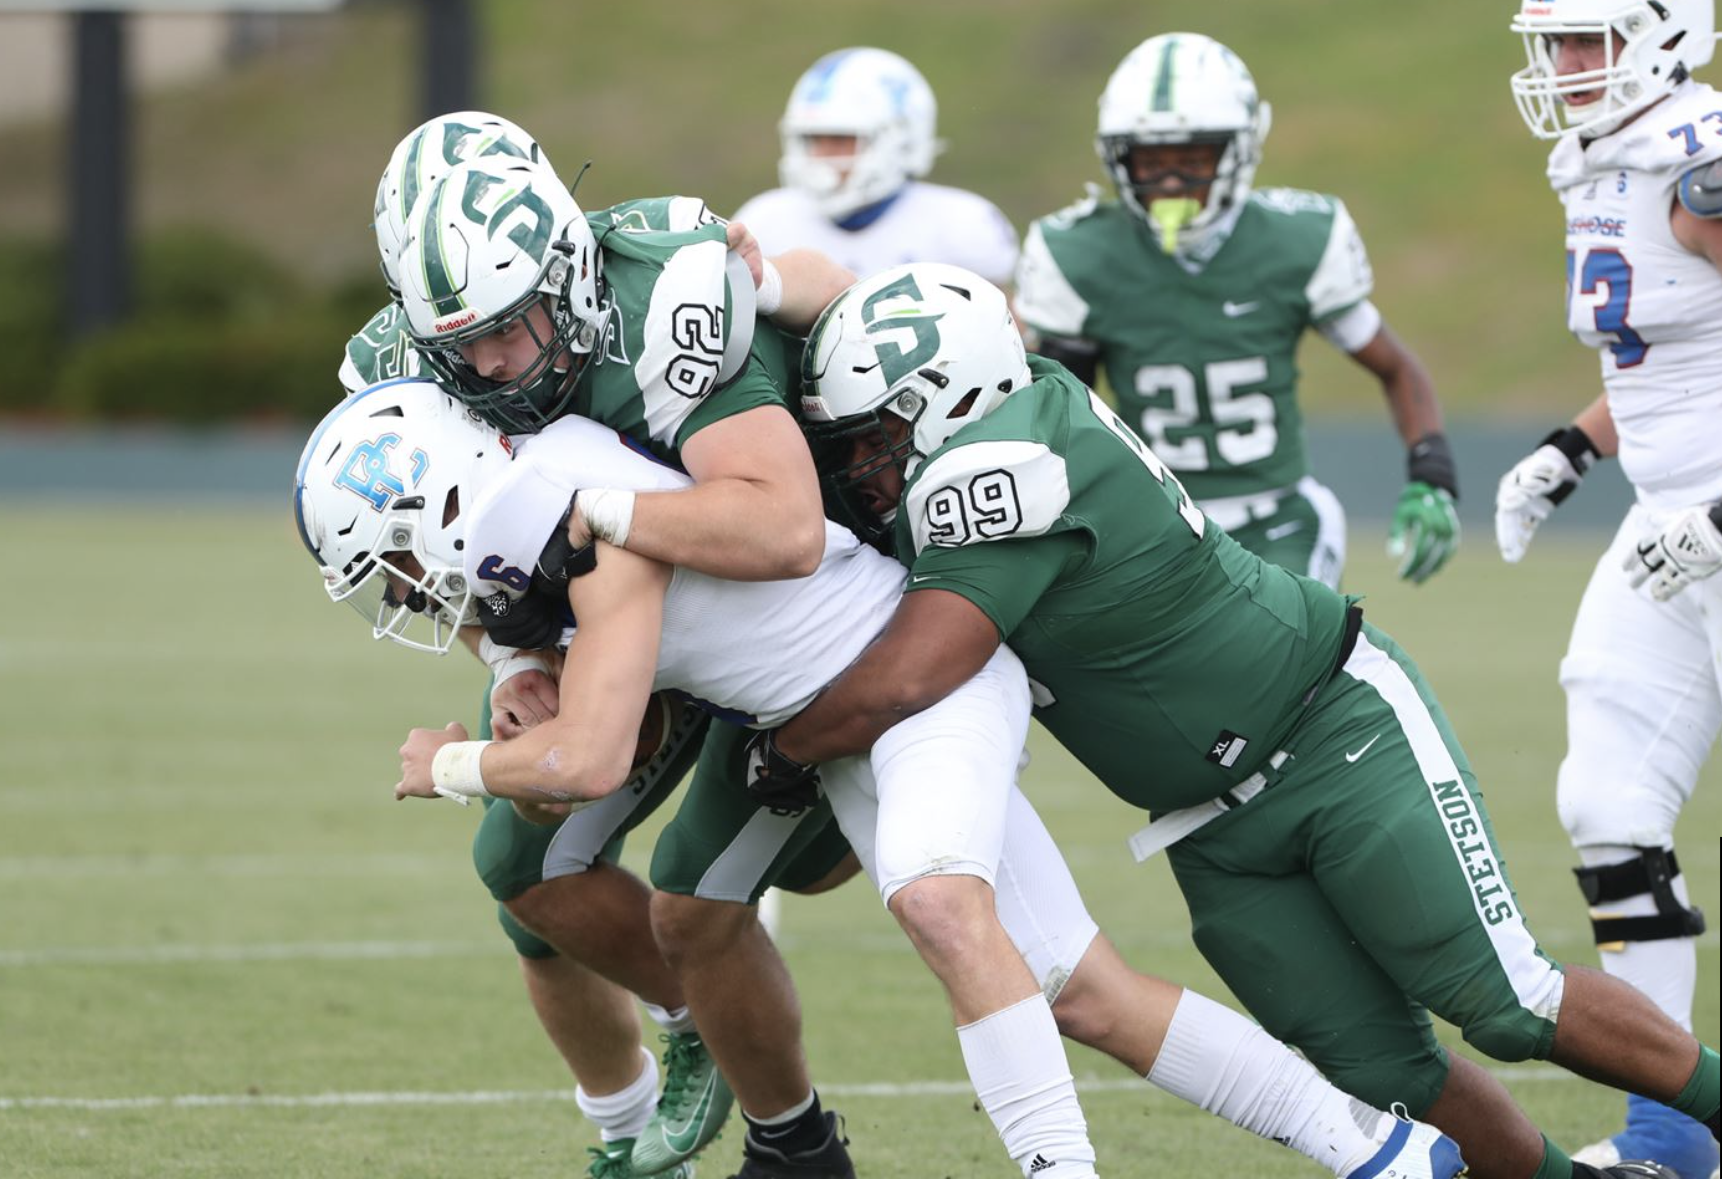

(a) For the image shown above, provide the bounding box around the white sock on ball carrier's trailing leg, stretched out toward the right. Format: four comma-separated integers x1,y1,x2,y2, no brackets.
1149,989,1393,1177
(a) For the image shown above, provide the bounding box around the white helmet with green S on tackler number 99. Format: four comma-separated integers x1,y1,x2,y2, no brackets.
801,262,1031,524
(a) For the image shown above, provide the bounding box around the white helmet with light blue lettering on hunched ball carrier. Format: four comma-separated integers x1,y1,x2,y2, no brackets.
293,379,511,655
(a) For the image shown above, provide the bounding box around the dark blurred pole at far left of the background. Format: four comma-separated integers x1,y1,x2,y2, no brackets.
65,12,131,338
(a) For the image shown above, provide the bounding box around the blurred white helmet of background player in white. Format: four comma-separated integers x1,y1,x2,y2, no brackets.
777,48,944,220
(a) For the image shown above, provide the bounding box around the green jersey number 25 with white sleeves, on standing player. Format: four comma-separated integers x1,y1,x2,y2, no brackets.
1016,188,1374,500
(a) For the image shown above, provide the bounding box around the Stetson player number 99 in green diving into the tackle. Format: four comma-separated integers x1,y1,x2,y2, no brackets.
771,264,1722,1177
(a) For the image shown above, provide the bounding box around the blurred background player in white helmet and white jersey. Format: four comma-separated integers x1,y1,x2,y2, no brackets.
735,47,1016,283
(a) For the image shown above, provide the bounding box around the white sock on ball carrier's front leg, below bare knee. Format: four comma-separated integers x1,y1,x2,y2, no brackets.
957,996,1095,1180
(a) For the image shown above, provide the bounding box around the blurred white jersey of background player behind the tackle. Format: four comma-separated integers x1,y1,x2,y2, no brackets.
732,181,1016,286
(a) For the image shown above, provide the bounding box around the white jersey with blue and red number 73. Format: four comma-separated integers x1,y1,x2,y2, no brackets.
1548,83,1722,508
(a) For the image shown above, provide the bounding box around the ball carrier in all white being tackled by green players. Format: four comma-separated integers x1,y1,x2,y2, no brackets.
349,377,1462,1177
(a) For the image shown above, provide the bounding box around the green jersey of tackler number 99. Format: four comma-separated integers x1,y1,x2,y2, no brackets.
895,357,1347,811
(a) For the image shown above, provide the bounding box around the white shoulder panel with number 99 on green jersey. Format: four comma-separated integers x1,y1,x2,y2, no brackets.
904,439,1071,553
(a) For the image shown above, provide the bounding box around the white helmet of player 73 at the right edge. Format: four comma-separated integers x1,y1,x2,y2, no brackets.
1512,0,1717,140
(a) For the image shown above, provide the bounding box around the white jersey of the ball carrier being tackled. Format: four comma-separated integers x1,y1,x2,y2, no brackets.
465,417,904,725
